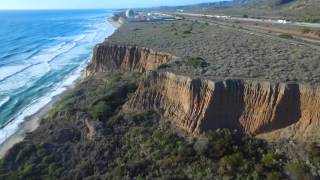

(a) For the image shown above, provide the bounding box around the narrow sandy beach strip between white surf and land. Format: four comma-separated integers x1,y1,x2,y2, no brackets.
0,16,122,159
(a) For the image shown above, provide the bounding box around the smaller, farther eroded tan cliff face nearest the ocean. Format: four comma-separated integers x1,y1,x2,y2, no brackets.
87,42,175,74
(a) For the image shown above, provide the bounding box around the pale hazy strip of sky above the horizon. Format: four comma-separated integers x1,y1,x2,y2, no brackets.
0,0,225,9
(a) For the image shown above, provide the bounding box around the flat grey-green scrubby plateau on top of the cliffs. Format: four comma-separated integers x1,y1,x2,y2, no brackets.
108,20,320,85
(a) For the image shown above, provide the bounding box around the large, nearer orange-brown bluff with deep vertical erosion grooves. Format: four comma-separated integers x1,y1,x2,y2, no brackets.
124,72,320,139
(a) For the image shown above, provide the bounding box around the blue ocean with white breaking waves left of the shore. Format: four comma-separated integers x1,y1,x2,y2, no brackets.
0,10,114,144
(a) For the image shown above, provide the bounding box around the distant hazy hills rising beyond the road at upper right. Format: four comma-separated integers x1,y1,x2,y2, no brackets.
161,0,320,22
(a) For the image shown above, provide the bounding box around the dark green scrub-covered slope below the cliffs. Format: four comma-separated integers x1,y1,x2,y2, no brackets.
0,72,320,180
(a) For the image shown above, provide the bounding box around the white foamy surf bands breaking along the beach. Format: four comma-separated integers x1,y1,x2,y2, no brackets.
0,11,114,144
